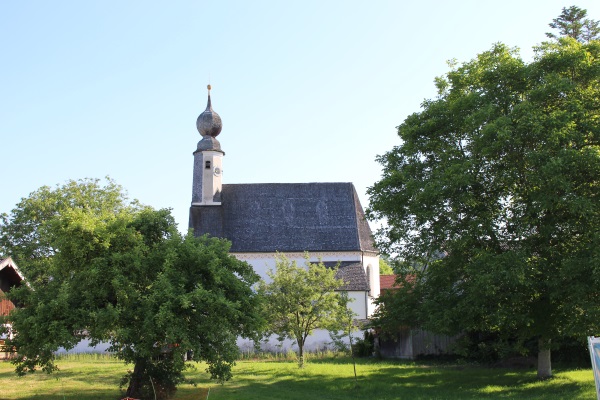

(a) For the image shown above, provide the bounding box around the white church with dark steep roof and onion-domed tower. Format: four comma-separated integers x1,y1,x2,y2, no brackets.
189,85,379,340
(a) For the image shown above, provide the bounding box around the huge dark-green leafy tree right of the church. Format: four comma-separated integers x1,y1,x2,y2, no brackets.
369,29,600,378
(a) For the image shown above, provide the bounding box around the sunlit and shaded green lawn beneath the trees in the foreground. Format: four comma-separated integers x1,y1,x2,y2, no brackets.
0,355,596,400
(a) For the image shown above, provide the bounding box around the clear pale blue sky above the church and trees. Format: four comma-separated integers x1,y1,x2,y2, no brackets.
0,0,600,230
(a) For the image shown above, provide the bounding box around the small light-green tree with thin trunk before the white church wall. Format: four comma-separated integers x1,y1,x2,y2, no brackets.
259,254,347,368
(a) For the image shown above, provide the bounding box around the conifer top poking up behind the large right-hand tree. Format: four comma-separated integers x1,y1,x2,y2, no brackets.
546,6,600,42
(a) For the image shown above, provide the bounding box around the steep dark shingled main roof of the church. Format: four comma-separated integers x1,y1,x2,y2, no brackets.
190,183,377,253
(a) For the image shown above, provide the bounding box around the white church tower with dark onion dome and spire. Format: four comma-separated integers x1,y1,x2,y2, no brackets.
192,85,225,206
